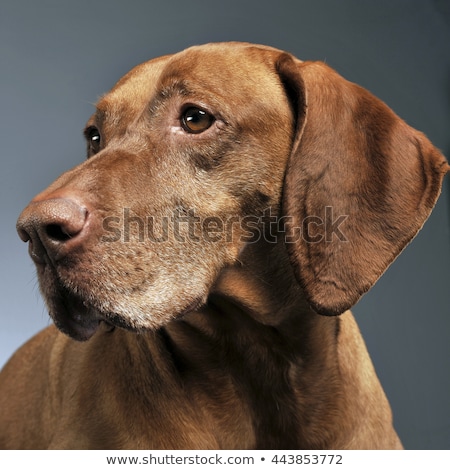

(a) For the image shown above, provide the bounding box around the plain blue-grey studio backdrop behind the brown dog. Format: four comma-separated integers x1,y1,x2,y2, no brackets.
0,0,450,449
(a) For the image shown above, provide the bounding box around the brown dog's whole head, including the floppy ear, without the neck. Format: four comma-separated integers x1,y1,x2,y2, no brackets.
18,43,448,340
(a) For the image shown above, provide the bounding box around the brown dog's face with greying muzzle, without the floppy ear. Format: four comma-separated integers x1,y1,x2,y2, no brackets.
15,46,293,339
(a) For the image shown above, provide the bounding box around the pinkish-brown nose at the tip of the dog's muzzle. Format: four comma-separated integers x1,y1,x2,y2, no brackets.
17,197,88,264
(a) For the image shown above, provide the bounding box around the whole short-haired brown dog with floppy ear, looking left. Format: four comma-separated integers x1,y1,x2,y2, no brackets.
0,43,449,449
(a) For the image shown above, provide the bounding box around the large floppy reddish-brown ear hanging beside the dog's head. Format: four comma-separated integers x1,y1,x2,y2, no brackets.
277,54,449,315
